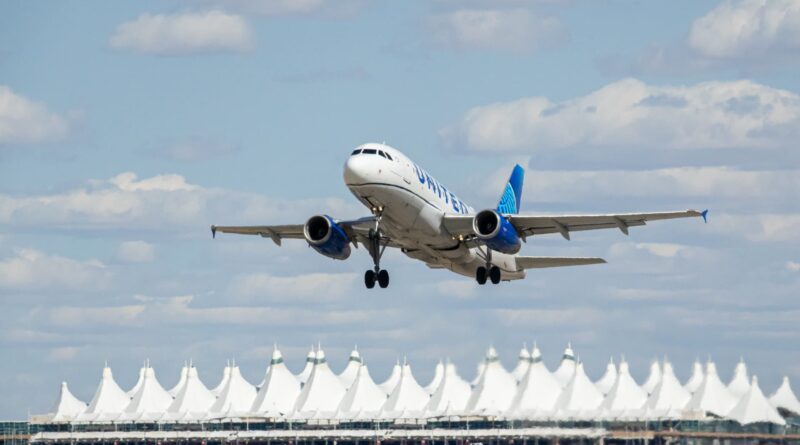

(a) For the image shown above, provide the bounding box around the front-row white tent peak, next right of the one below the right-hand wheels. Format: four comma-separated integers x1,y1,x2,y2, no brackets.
509,345,561,415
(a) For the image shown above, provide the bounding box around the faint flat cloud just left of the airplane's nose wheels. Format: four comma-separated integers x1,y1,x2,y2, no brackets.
230,273,357,300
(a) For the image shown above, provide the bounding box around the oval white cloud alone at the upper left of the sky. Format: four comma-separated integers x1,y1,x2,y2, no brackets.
109,10,253,55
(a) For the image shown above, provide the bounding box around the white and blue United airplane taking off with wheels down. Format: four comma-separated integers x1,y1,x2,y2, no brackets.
211,143,708,289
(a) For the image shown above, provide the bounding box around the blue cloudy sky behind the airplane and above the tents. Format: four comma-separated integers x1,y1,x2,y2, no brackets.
0,0,800,418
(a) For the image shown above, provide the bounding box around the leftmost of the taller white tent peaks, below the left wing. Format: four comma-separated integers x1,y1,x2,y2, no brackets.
250,346,300,416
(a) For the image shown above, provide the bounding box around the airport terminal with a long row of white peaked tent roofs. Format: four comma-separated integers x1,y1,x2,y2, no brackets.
3,345,800,445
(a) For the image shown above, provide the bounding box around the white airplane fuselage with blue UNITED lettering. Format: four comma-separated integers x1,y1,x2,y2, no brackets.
344,143,525,280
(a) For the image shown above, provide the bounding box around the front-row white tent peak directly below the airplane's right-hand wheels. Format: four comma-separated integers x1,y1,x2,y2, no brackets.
466,347,517,414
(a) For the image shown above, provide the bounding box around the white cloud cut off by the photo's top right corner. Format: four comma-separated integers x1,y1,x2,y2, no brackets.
688,0,800,59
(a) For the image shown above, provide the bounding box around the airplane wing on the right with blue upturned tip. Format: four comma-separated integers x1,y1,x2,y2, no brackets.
443,210,708,239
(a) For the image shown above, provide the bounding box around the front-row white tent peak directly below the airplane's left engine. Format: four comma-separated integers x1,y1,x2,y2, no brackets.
294,349,346,417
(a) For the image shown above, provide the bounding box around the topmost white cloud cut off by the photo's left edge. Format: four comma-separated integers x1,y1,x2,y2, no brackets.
0,85,70,146
